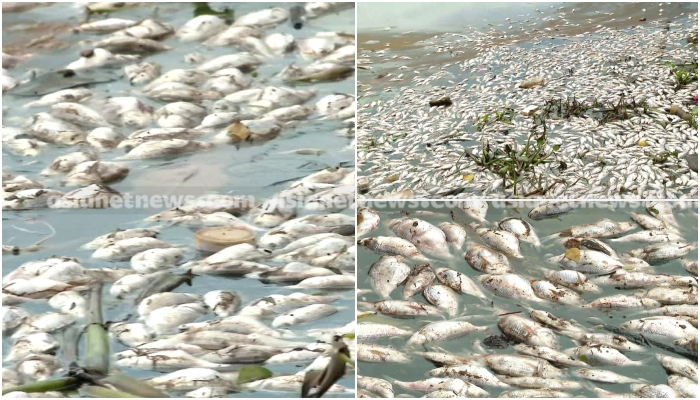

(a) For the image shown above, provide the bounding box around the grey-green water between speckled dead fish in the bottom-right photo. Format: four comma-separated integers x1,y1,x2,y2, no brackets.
357,201,698,397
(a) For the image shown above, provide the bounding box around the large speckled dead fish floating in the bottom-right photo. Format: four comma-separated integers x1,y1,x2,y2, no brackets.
357,201,698,397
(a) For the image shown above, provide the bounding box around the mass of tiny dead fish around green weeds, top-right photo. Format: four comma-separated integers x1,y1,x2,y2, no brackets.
357,14,698,199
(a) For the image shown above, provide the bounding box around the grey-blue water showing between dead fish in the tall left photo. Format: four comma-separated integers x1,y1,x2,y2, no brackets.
2,3,355,397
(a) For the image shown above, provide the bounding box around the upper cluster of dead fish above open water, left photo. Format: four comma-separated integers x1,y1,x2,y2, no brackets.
3,3,355,210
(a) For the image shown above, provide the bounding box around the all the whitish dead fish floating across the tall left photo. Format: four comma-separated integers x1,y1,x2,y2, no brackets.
2,3,356,397
